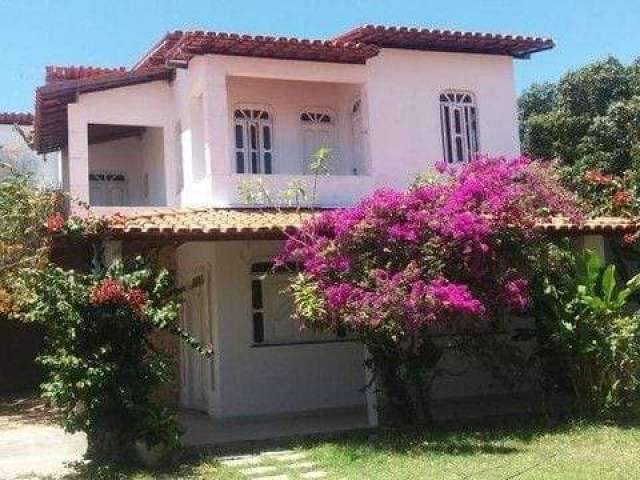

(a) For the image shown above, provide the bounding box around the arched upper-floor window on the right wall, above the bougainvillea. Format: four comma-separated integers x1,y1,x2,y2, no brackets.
440,91,479,163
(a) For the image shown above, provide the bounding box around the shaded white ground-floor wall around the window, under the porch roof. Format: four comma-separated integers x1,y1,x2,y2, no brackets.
178,241,365,417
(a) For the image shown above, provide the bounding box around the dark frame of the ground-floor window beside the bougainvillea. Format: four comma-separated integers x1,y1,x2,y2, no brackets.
247,258,353,348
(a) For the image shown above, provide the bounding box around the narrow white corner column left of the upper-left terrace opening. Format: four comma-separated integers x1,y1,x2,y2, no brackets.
67,104,89,213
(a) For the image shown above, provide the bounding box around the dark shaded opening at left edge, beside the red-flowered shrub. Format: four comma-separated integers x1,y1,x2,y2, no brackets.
0,317,44,394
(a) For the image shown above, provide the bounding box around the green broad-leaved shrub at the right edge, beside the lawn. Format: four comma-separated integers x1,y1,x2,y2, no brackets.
538,250,640,415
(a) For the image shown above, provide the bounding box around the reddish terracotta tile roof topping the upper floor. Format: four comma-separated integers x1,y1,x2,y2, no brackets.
35,25,554,153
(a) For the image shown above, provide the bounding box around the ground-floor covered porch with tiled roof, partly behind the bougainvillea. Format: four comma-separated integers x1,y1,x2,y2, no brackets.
94,208,636,445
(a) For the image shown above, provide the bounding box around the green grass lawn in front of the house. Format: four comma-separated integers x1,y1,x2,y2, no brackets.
74,422,640,480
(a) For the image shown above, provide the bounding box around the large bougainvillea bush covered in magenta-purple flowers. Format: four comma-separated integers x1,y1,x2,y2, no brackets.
279,157,580,421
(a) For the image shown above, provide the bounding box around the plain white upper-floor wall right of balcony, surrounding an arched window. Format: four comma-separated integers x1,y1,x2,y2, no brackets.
367,49,519,188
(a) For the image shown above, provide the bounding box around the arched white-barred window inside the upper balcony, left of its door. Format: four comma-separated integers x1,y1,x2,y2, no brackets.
233,108,273,174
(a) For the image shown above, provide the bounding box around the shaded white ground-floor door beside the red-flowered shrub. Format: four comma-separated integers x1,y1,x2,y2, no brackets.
180,266,213,412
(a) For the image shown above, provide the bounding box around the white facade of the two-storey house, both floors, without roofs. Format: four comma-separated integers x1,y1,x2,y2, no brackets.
63,44,519,423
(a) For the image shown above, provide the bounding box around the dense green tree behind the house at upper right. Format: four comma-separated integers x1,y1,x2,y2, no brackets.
519,57,640,179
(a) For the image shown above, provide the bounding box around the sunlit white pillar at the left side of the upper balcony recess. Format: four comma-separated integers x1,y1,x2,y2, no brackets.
203,62,232,176
